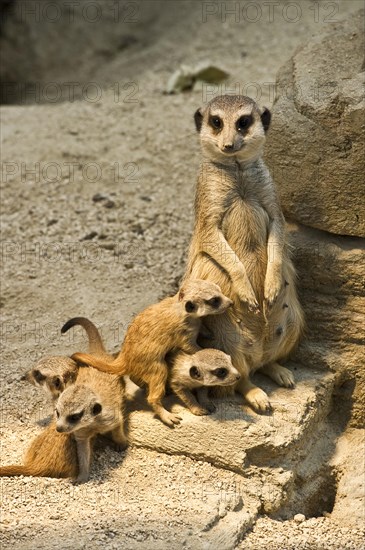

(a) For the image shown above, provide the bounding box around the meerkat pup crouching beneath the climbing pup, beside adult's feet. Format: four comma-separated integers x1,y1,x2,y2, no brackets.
167,349,241,416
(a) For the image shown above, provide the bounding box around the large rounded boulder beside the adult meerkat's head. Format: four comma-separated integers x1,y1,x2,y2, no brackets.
266,10,365,237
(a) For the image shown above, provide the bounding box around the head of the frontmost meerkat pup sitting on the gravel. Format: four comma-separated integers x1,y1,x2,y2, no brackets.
55,384,103,433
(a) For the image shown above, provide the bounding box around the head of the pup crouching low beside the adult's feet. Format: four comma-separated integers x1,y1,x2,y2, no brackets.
189,349,241,387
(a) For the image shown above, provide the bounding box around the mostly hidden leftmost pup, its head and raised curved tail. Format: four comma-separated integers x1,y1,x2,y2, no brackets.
22,317,110,402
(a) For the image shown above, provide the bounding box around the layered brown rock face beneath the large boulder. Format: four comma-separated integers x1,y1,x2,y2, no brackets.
289,224,365,428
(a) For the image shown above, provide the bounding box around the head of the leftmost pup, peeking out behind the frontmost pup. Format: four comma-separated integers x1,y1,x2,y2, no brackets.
22,355,78,401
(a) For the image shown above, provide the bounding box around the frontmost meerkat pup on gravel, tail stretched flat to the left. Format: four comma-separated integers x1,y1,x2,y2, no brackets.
0,367,127,483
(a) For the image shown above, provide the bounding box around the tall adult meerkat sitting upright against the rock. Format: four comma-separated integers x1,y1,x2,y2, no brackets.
185,95,303,411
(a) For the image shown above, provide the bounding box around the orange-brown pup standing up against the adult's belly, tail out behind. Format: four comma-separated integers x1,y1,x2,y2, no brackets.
72,280,232,427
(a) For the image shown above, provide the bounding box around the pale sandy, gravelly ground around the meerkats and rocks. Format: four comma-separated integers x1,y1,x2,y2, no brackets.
1,0,363,550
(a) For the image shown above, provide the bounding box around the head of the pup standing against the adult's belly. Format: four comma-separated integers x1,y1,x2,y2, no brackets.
178,279,233,317
